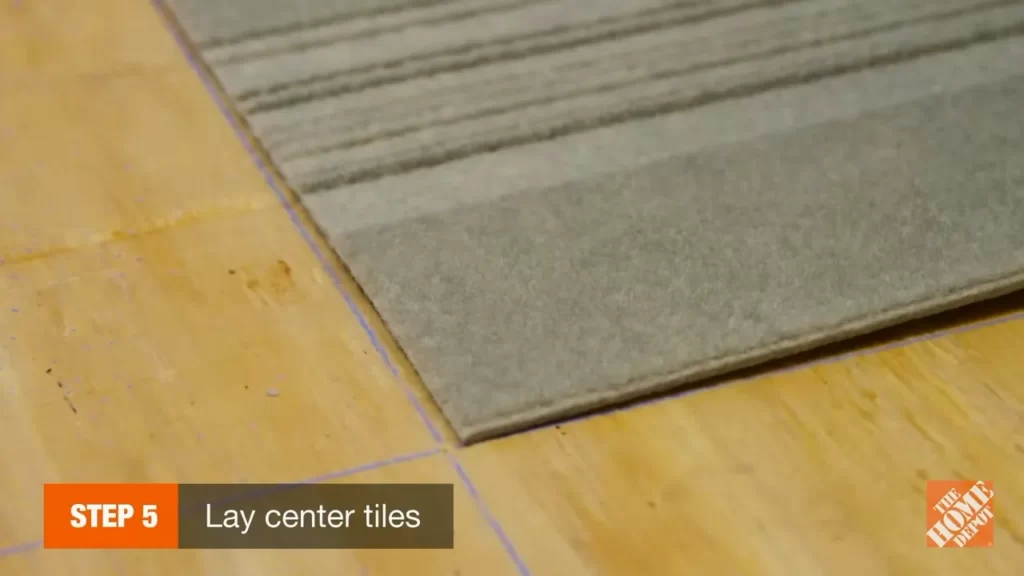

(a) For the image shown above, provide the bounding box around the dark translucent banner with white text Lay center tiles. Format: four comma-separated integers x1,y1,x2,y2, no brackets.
178,484,455,549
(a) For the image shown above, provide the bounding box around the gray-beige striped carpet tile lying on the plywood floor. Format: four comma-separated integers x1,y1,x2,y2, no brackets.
163,0,1024,442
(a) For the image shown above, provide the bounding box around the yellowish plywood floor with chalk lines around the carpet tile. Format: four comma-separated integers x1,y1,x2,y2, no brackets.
0,0,1024,576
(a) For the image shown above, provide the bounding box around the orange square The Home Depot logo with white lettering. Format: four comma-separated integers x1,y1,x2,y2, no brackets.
927,480,995,548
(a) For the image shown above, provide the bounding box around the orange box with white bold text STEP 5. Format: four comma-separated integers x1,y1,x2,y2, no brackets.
43,484,178,548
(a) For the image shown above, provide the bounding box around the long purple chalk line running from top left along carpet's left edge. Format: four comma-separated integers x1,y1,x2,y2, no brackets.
150,0,530,576
